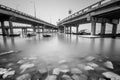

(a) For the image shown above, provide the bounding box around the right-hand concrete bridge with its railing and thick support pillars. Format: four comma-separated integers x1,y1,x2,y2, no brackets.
58,0,120,36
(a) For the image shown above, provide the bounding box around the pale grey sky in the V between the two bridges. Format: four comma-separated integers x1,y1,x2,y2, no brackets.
0,0,99,24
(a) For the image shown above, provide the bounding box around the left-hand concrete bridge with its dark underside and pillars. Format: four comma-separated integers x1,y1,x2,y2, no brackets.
0,5,57,35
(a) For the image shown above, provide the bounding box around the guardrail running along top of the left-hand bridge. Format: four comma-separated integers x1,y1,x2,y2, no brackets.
0,4,54,26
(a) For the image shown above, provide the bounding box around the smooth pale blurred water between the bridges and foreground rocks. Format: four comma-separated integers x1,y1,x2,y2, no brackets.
0,33,120,62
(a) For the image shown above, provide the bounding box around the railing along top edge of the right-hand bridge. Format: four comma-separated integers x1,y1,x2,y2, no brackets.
60,0,114,23
